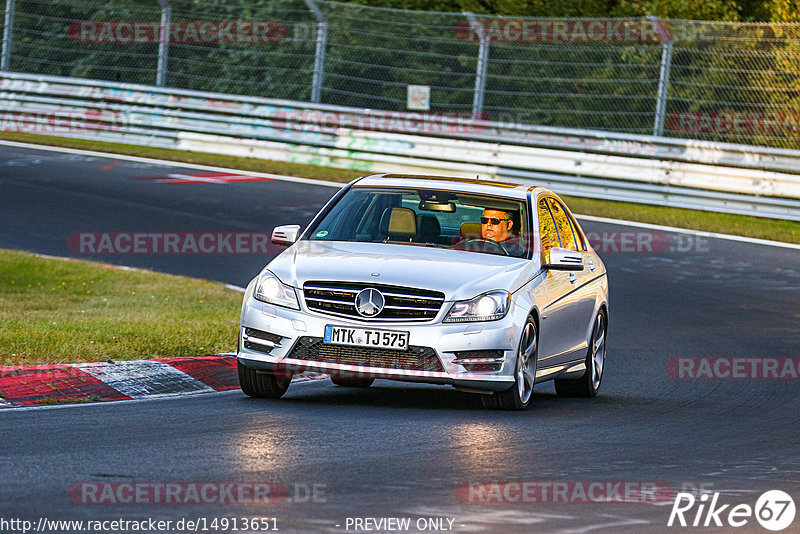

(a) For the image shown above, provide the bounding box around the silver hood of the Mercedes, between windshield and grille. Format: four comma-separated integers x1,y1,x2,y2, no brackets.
267,240,536,300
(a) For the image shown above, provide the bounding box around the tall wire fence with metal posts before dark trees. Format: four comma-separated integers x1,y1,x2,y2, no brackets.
0,0,800,148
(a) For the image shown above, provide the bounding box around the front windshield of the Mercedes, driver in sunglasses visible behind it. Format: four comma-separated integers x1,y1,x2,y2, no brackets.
308,187,530,258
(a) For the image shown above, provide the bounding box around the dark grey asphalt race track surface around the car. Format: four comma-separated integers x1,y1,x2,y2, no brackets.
0,147,800,533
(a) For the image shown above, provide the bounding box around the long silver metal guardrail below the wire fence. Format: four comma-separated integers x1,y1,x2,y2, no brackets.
0,73,800,220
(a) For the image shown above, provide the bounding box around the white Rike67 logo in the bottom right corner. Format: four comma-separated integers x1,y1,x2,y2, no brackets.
667,490,795,532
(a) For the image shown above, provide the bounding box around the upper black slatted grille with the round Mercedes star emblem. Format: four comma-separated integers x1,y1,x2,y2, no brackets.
303,282,444,321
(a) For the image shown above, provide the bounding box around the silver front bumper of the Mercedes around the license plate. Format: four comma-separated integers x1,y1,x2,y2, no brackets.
238,291,524,391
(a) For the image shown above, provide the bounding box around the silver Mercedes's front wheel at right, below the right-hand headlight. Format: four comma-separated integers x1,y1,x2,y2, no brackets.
481,316,539,410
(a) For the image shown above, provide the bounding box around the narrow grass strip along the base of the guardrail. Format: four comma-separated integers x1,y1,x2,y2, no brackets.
0,132,800,243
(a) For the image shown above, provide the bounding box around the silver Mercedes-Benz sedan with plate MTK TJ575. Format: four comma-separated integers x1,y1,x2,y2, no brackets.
238,174,608,410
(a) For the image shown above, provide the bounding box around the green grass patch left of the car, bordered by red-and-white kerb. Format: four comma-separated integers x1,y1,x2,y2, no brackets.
0,250,242,366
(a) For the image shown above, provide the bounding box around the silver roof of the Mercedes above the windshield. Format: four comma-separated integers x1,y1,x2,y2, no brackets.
354,174,551,200
